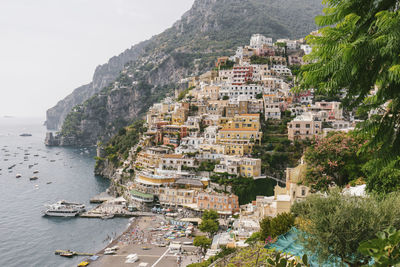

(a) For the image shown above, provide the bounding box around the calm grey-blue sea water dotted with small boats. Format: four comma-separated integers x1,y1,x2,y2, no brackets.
0,118,128,266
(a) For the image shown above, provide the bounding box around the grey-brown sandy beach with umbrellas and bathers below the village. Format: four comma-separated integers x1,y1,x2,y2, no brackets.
90,215,199,267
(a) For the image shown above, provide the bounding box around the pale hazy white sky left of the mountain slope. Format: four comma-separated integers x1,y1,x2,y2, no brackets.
0,0,194,117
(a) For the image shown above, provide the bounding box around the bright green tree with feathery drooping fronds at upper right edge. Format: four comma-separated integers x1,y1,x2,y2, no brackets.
299,0,400,174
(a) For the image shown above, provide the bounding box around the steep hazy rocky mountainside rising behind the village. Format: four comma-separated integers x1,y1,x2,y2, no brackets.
47,0,322,145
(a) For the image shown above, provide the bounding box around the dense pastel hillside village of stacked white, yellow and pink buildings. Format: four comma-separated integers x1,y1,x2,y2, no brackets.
98,33,355,256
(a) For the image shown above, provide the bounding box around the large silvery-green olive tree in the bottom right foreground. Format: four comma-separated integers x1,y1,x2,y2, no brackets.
291,190,400,266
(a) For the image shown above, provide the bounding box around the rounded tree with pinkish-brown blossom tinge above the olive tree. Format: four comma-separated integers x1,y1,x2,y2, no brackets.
305,132,367,190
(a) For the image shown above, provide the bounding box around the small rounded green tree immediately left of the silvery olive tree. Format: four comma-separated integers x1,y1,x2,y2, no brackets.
260,212,295,241
